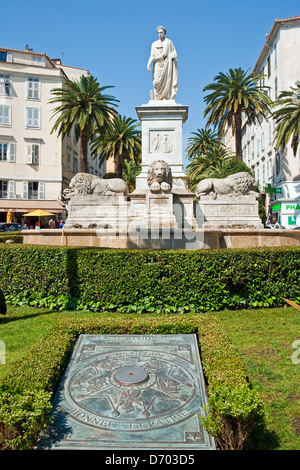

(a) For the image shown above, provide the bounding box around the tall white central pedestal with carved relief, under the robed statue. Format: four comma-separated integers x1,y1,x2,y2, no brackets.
136,101,188,191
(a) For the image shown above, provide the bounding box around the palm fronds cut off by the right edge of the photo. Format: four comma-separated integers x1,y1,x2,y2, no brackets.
273,80,300,157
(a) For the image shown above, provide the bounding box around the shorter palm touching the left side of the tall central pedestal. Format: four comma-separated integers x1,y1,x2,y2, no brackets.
91,115,141,178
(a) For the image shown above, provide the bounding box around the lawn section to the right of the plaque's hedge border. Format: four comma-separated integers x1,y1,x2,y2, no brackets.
216,308,300,450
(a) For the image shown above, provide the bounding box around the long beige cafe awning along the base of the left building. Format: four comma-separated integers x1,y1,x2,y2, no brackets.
0,199,66,214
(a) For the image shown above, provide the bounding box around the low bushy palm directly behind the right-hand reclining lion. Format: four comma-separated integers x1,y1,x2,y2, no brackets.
186,145,235,191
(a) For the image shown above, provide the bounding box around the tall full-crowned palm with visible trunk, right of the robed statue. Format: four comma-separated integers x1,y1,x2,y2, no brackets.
203,68,271,160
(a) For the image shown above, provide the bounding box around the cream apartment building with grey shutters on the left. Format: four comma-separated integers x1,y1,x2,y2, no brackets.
0,47,105,224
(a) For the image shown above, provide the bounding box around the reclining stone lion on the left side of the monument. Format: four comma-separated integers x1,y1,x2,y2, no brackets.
64,173,129,199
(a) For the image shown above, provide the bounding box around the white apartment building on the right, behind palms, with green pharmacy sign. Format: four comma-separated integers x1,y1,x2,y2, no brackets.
242,16,300,228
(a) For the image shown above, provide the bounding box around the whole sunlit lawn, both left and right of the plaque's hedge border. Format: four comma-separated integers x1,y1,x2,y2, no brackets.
0,306,300,450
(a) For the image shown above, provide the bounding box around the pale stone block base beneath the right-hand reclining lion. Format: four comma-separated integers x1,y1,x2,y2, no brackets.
196,194,264,229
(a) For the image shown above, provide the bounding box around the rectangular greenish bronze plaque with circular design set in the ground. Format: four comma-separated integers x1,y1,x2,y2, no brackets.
36,335,215,450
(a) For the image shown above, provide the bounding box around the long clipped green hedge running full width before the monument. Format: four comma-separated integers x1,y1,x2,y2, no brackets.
0,245,300,313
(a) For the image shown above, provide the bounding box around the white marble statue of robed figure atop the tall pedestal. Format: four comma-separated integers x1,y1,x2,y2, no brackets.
147,26,178,101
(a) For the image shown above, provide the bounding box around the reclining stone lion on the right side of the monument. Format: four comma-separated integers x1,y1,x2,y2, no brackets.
196,171,258,199
